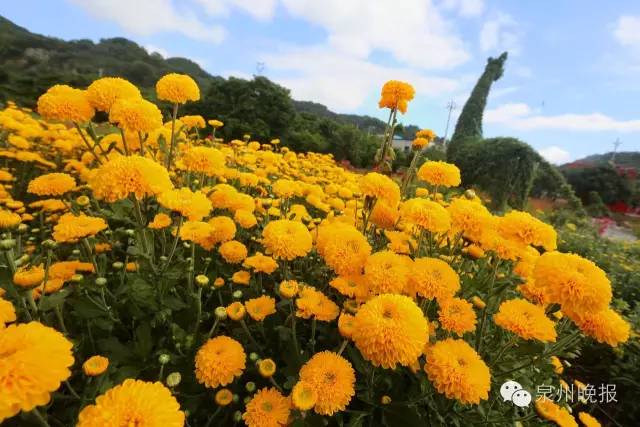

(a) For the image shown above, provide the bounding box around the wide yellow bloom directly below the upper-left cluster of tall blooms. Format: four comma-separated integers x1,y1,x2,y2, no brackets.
89,156,173,203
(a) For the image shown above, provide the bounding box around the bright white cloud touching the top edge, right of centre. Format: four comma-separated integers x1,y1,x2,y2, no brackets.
281,0,469,69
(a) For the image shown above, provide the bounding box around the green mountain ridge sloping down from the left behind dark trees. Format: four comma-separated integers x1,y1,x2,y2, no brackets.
0,16,419,139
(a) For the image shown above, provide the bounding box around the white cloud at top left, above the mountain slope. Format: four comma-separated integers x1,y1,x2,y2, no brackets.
70,0,225,43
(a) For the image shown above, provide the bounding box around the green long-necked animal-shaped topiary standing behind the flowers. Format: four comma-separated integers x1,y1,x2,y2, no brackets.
447,52,582,212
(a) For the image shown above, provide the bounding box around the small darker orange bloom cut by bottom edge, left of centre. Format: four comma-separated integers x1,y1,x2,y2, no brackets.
242,388,291,427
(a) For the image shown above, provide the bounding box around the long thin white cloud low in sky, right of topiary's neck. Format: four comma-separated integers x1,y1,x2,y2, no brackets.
484,103,640,132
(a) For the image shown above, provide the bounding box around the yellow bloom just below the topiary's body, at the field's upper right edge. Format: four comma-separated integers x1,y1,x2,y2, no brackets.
498,211,557,251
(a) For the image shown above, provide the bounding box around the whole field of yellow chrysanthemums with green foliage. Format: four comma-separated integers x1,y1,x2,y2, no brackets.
0,74,634,427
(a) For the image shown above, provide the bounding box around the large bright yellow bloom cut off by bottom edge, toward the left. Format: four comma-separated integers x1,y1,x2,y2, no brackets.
77,379,185,427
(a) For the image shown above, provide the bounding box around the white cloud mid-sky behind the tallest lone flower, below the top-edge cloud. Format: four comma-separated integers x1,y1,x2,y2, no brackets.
261,46,459,111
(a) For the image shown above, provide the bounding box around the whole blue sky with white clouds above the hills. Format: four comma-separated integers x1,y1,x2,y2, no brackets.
0,0,640,163
